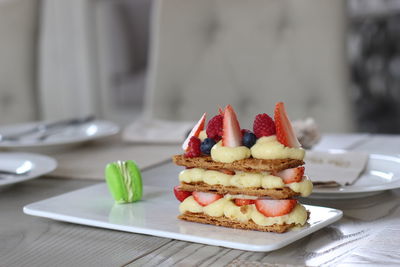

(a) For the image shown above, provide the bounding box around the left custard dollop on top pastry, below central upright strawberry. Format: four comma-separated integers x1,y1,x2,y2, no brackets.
211,141,251,163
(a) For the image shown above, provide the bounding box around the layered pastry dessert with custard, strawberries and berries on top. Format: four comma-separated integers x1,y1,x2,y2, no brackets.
173,102,313,233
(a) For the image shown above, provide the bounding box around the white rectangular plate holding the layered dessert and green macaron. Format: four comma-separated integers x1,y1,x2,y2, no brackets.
24,183,342,251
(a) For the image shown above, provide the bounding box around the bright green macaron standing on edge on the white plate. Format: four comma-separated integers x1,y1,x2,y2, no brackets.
105,160,143,204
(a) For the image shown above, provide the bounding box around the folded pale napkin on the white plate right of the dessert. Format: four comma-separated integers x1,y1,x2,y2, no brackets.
304,151,368,187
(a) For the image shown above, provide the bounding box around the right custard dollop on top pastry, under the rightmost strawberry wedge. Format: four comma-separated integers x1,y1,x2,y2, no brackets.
251,135,305,160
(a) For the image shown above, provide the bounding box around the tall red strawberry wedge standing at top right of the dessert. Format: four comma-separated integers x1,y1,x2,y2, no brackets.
274,102,301,148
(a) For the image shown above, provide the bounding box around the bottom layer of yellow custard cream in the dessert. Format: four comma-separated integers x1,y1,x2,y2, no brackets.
179,196,307,226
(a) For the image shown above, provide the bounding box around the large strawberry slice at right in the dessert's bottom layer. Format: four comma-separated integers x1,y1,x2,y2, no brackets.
255,199,297,217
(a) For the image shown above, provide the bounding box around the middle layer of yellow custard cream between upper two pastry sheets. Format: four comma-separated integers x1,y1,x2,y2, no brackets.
179,168,313,197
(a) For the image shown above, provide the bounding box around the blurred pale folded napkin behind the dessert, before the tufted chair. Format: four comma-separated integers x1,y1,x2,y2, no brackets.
122,118,195,144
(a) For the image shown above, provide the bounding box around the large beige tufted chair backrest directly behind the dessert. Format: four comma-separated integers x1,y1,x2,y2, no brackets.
146,0,352,132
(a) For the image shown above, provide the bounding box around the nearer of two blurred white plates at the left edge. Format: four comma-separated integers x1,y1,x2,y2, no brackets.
0,152,57,187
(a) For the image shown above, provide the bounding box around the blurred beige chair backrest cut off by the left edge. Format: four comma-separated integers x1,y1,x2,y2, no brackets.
0,0,39,125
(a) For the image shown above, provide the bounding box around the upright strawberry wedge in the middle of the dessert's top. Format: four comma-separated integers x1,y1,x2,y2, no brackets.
222,105,242,147
